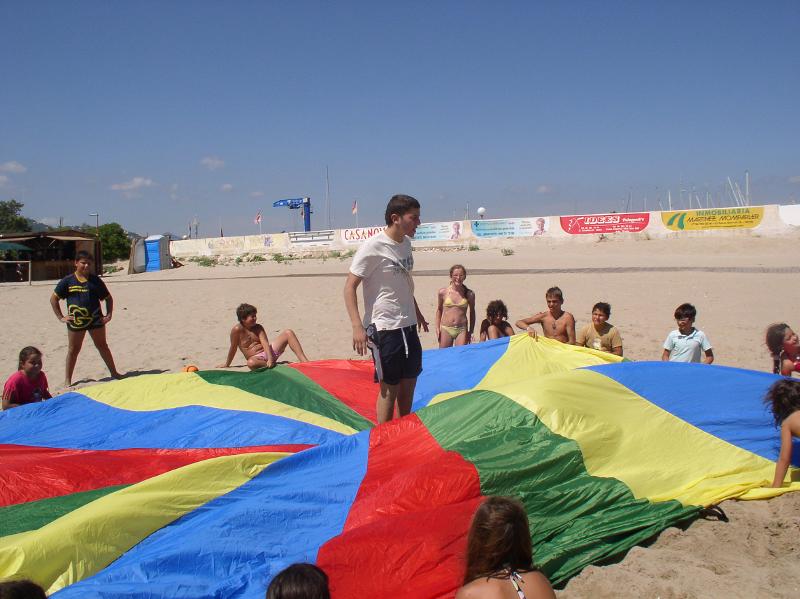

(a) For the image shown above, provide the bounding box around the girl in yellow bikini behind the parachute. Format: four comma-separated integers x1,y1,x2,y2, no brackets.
436,264,475,347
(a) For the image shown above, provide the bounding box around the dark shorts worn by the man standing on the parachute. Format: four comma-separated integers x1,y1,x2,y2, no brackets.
367,325,422,385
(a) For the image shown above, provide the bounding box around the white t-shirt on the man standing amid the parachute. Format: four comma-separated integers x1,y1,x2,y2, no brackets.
350,231,417,331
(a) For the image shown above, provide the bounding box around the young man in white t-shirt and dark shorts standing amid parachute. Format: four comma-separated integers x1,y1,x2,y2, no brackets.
344,195,428,423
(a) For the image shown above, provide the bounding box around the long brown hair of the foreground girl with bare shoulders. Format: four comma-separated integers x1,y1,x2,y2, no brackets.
464,497,534,584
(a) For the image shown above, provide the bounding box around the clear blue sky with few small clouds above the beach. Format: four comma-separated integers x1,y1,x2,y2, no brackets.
0,0,800,236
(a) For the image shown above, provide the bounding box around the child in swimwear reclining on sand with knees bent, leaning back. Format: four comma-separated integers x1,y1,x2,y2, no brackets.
218,304,308,370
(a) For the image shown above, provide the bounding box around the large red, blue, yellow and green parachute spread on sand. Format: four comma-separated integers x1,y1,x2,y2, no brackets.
0,335,800,599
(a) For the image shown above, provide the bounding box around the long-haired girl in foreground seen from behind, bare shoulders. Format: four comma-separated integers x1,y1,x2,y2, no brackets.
456,497,555,599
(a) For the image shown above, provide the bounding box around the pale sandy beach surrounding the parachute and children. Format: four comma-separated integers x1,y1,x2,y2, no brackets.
0,236,800,599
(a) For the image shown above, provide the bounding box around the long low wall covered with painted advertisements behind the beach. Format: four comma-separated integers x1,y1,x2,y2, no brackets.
171,204,800,258
